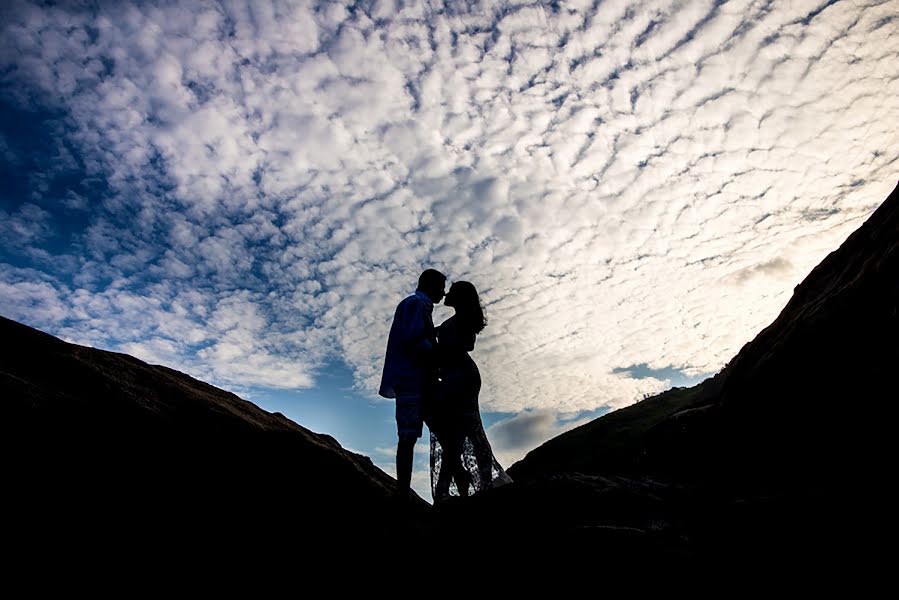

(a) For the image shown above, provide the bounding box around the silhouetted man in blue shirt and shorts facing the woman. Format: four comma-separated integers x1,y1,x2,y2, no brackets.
378,269,446,503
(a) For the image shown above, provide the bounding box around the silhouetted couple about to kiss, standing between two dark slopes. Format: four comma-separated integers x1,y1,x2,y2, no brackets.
379,269,511,502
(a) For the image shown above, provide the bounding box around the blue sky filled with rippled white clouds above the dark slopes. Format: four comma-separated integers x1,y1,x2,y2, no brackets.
0,0,899,498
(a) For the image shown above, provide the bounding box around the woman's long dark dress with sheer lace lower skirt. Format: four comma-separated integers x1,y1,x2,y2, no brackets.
428,316,512,502
